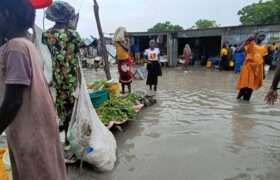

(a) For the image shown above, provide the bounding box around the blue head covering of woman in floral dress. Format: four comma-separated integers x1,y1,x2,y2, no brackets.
46,1,75,24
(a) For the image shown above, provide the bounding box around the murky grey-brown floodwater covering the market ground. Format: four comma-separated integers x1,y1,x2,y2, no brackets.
69,69,280,180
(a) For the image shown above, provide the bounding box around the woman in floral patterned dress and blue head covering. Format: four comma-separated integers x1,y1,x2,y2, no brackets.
42,1,82,147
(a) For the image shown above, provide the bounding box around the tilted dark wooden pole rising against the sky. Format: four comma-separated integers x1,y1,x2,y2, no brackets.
93,0,112,80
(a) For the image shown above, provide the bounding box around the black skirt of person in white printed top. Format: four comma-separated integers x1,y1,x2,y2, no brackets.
146,61,162,85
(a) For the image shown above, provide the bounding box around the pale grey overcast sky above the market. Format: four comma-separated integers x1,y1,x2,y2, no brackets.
37,0,259,37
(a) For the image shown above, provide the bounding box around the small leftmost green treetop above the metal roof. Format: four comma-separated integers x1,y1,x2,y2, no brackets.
148,21,184,32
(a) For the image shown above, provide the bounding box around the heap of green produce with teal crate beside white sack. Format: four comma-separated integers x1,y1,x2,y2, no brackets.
88,81,156,128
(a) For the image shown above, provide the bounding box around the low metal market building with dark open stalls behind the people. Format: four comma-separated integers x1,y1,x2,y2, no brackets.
128,24,280,66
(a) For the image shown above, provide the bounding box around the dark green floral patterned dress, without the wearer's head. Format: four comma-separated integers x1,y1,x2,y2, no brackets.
43,28,82,128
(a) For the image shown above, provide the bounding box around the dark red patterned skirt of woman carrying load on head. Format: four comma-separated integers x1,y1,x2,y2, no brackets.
118,59,132,84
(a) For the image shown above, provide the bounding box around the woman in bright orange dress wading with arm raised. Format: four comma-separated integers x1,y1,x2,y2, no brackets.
237,36,267,101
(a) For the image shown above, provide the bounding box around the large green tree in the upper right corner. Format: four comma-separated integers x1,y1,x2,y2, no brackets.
238,0,280,25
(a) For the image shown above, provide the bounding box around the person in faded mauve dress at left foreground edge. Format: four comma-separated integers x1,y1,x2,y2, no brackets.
0,0,66,180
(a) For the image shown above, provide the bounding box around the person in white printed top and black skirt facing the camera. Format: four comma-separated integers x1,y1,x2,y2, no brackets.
144,40,162,91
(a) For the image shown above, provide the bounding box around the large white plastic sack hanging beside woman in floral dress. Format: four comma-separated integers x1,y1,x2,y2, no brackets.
67,77,117,171
